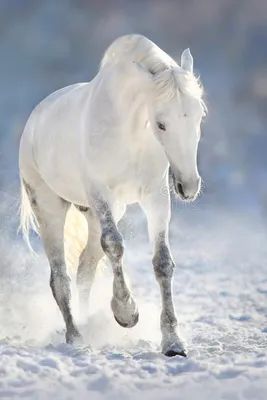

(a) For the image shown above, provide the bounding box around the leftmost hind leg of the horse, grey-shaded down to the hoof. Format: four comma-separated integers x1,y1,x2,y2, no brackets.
24,181,82,343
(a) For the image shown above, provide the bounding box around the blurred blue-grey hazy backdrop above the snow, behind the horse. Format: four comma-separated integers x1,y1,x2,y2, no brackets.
0,0,267,292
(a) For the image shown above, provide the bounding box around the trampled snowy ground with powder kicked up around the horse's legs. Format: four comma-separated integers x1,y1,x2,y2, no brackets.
0,205,267,400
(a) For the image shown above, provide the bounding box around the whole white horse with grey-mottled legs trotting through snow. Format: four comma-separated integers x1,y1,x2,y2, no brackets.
19,35,205,356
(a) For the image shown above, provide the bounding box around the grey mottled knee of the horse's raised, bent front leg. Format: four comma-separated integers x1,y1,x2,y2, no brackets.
101,229,124,261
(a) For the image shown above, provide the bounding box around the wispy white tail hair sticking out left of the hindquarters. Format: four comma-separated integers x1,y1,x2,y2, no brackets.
19,177,39,255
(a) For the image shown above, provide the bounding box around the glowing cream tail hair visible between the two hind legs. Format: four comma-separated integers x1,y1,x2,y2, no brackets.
64,205,88,269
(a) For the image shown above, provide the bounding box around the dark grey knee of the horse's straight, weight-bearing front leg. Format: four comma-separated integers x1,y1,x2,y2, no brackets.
152,245,175,281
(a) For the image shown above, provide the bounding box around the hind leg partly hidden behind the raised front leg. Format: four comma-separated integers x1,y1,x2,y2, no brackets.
77,207,104,319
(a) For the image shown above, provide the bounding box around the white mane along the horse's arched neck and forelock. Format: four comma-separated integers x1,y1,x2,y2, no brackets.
101,35,206,109
